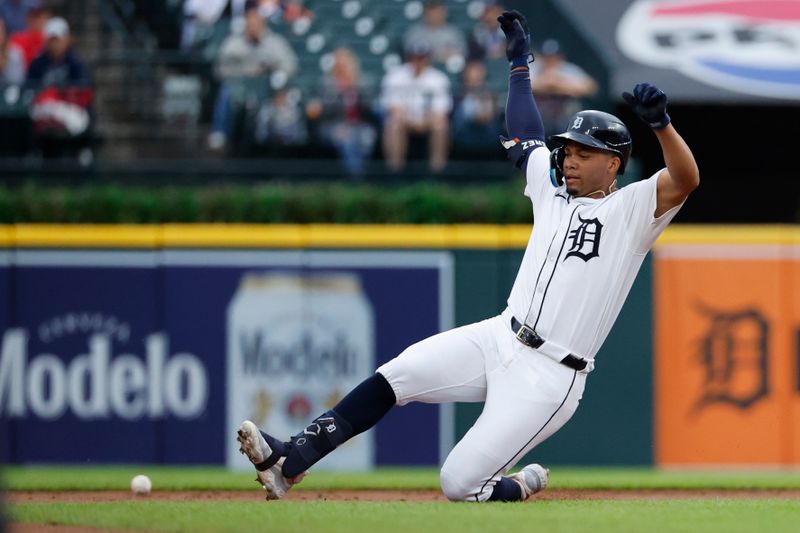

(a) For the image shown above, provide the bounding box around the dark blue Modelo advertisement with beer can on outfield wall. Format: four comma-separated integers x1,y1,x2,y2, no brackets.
0,250,452,469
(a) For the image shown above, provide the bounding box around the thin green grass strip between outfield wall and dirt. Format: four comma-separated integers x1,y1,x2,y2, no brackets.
3,466,800,490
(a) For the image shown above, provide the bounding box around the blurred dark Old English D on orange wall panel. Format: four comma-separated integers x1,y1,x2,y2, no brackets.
695,308,769,411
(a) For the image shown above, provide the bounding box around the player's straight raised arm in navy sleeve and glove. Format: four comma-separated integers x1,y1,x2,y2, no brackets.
497,11,544,168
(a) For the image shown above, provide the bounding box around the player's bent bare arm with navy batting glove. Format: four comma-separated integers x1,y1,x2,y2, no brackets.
622,83,700,218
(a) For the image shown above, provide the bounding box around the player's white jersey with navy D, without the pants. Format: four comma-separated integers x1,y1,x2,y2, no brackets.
508,148,682,368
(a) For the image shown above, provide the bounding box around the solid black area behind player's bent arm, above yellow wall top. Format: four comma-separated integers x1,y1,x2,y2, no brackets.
617,105,800,224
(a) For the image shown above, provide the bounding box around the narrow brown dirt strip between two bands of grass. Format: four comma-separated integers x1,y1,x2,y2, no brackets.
8,489,800,504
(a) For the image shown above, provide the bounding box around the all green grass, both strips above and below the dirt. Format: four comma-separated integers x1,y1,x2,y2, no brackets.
3,466,800,533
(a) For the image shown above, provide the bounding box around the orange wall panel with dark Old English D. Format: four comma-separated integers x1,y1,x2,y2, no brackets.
654,245,800,466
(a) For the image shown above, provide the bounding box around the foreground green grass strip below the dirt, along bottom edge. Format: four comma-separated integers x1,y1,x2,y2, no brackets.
12,500,800,533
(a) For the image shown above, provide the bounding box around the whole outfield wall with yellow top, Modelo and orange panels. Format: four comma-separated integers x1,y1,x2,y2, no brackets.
0,225,800,468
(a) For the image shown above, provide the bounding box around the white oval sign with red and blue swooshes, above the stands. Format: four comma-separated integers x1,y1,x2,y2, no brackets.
616,0,800,100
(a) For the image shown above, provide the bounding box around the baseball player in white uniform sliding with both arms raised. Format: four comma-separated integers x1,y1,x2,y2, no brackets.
237,11,699,502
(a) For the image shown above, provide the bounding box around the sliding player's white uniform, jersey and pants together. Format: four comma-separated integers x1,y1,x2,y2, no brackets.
378,143,680,501
